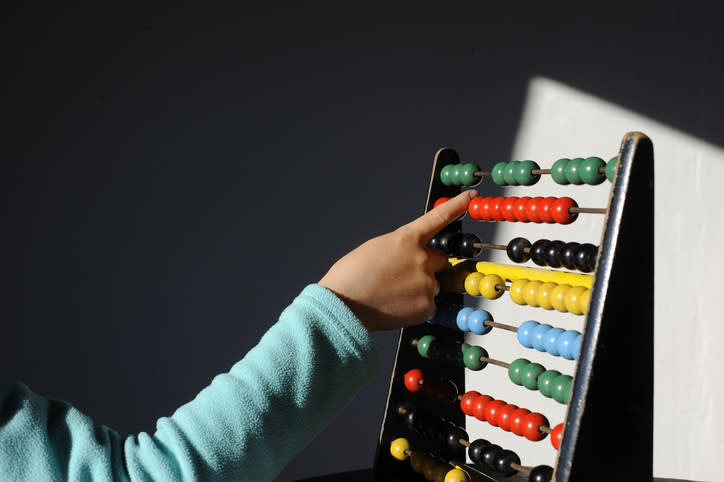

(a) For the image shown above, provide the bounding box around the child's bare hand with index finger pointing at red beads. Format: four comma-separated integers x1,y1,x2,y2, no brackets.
319,190,478,331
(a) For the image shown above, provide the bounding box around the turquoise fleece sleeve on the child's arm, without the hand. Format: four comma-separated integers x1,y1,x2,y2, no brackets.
0,285,378,481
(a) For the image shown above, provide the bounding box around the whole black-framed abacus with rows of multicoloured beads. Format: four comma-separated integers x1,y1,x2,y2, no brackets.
374,132,654,482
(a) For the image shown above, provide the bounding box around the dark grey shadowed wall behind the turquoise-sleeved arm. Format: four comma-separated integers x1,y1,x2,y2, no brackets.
0,2,724,481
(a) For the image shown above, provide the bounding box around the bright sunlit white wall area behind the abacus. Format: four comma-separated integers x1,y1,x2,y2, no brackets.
466,78,724,481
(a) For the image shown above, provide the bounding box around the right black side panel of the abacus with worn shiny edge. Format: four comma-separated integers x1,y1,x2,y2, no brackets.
555,133,654,481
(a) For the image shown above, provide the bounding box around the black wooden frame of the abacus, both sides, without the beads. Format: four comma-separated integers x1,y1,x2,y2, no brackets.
374,132,654,481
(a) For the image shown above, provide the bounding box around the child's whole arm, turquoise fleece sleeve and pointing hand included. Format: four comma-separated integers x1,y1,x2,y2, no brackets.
0,190,476,481
